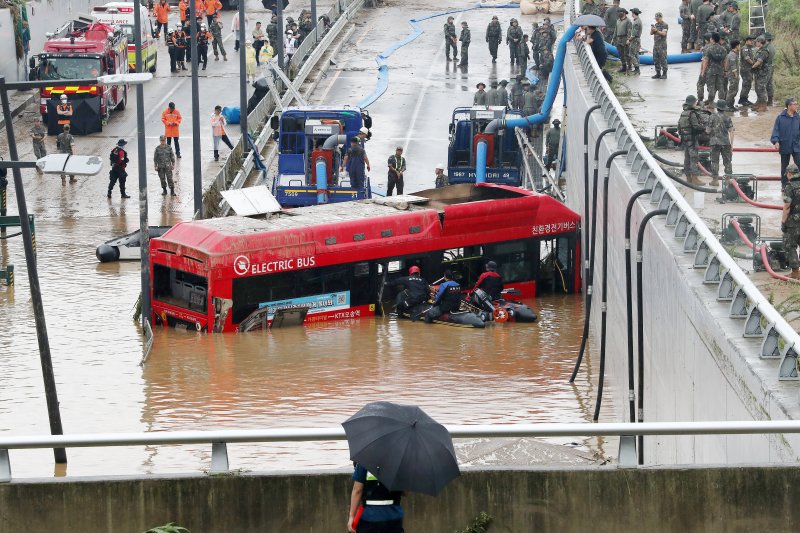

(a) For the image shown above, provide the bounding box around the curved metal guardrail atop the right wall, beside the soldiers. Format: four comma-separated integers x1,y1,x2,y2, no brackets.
565,2,800,381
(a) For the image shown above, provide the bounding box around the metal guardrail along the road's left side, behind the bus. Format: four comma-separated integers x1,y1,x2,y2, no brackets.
203,0,364,216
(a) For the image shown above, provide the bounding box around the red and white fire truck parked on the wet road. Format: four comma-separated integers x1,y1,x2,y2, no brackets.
30,17,128,134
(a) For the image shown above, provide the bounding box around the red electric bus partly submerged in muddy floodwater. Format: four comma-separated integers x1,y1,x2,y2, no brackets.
150,184,580,331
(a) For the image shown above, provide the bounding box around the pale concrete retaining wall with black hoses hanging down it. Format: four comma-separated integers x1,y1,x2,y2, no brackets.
565,45,800,464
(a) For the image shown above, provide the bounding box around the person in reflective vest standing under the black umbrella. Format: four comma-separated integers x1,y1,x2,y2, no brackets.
347,463,404,533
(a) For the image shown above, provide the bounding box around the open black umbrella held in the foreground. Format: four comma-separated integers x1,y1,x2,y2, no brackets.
342,402,460,496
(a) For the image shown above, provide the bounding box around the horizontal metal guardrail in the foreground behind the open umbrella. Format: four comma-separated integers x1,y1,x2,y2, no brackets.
0,420,800,483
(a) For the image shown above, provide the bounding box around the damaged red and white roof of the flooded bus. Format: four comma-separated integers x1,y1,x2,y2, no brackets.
153,184,580,256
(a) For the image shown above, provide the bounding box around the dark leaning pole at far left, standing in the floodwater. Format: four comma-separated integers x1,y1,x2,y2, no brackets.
0,76,67,464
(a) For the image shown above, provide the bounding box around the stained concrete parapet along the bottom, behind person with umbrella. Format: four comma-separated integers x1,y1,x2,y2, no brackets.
0,467,800,533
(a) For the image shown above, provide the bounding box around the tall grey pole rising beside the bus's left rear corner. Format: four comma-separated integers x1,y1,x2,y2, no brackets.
133,0,151,328
